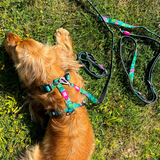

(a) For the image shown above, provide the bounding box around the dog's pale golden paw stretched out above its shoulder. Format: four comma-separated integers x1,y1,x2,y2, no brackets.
55,28,75,58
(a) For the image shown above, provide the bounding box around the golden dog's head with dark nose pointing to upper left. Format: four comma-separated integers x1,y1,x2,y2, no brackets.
5,32,64,87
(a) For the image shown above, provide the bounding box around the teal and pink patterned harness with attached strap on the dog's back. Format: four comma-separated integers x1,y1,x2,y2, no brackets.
40,73,99,117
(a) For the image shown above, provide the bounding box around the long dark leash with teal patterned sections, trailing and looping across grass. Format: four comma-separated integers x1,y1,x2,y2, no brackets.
82,0,160,103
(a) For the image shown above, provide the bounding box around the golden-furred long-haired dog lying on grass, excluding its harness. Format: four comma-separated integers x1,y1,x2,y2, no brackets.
5,28,94,160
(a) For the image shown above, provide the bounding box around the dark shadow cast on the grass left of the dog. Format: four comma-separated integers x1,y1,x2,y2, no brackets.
0,43,48,156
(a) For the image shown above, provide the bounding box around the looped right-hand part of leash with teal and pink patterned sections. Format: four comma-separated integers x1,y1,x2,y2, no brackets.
99,16,160,104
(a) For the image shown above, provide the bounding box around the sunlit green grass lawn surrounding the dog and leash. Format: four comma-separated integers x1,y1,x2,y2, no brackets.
0,0,160,160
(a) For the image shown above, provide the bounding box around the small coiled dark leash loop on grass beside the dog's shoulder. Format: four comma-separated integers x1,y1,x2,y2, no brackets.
78,51,108,78
